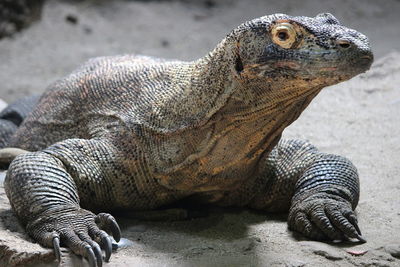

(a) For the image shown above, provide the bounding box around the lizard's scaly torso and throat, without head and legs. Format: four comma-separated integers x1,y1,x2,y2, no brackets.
11,50,319,209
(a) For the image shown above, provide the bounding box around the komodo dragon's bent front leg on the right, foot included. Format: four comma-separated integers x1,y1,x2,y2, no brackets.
250,140,365,242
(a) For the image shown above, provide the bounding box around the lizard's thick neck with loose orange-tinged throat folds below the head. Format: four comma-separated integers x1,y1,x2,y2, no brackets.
149,39,324,192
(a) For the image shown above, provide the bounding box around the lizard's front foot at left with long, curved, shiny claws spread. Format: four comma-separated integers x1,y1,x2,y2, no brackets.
26,208,121,267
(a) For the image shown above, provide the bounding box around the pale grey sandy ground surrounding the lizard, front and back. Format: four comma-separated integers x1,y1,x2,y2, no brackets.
0,0,400,266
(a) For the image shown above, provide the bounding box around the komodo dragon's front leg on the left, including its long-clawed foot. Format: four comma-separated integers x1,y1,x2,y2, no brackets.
5,139,122,266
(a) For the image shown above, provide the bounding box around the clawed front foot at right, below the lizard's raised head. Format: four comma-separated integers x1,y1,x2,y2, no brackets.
288,195,366,242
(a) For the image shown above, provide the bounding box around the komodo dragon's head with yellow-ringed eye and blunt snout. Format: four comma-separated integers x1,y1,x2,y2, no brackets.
231,13,373,87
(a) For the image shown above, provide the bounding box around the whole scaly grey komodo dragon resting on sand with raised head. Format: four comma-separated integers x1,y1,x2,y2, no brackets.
2,13,373,266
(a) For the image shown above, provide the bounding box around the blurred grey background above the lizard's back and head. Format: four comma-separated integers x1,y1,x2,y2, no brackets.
0,0,400,102
